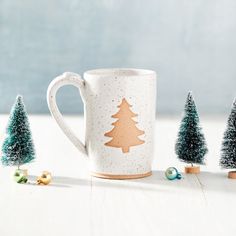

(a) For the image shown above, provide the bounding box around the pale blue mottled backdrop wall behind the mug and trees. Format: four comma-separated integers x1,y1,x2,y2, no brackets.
0,0,236,114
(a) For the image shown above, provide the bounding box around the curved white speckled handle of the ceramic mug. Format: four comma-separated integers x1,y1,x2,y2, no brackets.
47,72,87,156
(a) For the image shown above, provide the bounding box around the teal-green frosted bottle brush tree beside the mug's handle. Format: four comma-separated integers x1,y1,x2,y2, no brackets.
1,95,35,169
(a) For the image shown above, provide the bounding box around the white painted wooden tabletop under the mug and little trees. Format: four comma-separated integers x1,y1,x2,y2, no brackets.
0,115,236,236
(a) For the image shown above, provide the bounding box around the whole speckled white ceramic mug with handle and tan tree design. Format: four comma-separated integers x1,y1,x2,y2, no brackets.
47,69,156,179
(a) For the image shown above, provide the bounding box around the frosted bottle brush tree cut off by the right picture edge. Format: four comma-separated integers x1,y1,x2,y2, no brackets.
220,100,236,179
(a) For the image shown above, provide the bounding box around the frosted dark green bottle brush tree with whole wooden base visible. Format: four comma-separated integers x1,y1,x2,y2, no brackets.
175,92,208,173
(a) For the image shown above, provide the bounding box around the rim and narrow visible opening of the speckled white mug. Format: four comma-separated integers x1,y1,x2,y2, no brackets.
84,68,156,77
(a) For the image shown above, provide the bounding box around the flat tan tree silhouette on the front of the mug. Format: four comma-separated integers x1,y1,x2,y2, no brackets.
104,98,144,153
